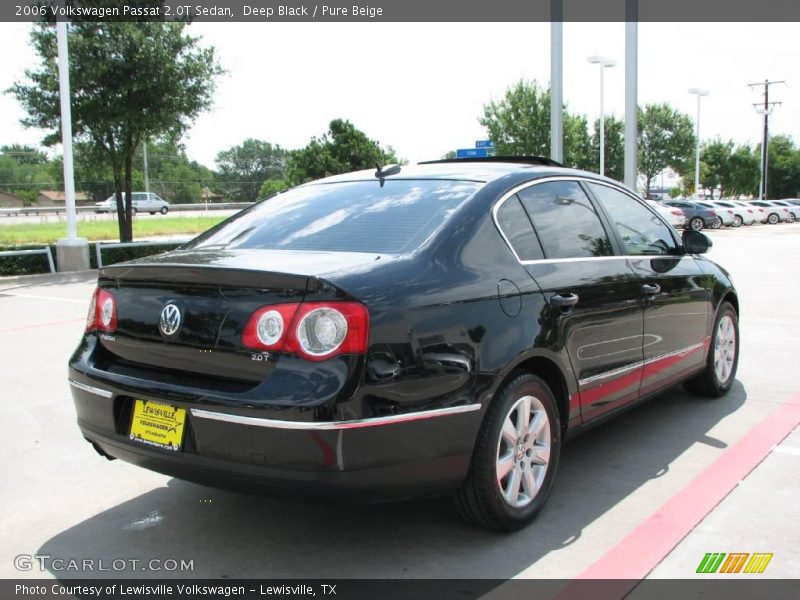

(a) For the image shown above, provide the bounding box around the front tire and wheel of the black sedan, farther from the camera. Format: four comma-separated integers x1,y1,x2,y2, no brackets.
683,302,739,398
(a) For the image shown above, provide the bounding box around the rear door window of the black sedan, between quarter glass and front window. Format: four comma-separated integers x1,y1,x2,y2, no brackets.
519,181,613,258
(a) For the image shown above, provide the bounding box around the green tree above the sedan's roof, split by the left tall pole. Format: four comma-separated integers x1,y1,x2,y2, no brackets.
478,79,591,169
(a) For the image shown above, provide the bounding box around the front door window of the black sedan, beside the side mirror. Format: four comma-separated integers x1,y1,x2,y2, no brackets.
589,183,677,256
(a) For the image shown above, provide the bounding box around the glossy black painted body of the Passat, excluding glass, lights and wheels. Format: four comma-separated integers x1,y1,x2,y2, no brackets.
69,164,738,499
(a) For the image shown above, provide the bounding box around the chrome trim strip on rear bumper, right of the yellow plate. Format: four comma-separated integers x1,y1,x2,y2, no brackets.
191,404,481,431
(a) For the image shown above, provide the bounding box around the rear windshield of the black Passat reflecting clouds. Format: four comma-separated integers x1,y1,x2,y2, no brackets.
188,180,482,254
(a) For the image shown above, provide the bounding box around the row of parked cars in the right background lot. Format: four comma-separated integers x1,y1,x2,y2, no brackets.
647,199,800,231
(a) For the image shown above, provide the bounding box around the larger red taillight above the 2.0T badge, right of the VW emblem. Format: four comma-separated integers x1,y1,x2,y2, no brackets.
242,302,369,361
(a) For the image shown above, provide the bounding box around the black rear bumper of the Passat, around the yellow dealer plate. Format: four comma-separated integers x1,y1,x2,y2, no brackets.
70,370,482,502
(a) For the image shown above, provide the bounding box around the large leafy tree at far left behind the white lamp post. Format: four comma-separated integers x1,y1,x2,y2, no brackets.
10,21,221,241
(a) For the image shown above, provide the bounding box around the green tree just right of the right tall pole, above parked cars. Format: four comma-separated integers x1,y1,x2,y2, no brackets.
638,104,695,195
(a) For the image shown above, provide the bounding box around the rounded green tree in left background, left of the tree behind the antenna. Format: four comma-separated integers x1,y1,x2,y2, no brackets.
215,138,288,202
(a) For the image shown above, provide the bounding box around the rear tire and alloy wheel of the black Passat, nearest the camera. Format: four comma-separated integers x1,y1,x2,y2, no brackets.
454,372,561,531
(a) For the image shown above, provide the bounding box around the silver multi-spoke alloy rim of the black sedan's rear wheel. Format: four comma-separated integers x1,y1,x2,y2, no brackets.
496,396,551,508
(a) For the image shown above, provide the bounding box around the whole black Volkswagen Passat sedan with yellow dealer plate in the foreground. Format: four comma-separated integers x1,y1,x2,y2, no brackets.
69,158,739,530
